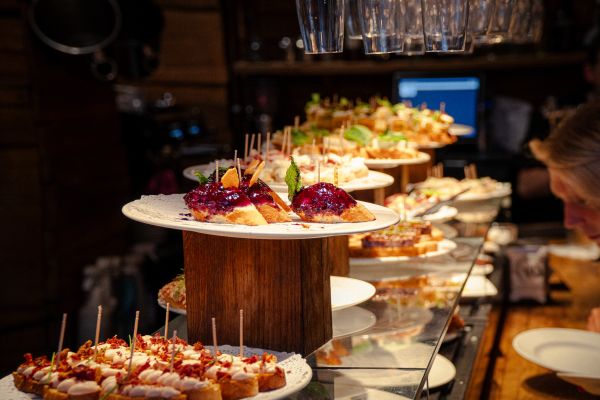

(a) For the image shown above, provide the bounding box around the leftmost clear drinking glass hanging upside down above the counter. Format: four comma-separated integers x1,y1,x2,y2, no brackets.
296,0,344,54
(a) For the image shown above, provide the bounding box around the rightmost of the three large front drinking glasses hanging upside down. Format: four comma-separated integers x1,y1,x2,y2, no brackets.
421,0,469,53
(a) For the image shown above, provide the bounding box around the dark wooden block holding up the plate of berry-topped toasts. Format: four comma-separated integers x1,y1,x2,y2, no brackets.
183,231,348,355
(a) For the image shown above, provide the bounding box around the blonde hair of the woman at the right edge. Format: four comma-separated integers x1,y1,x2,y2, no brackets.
529,102,600,197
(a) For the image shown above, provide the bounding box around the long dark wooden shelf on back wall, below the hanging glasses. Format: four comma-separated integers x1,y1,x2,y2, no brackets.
233,52,585,76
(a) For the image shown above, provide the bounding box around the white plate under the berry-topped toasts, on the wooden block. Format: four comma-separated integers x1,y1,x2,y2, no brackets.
122,193,400,239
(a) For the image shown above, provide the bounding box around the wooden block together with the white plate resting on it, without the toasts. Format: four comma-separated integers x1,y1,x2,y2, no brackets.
123,194,399,354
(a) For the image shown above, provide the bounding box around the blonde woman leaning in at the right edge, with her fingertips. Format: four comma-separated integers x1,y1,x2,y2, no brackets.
529,102,600,332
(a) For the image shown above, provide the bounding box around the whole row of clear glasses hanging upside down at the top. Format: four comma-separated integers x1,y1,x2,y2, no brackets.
296,0,544,55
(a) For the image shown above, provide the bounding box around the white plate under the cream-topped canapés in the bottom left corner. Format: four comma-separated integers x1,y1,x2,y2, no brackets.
0,345,312,400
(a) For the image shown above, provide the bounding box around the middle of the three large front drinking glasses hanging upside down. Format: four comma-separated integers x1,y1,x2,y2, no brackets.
358,0,404,54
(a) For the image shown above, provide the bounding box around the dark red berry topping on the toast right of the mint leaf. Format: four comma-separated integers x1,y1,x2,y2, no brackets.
292,182,356,215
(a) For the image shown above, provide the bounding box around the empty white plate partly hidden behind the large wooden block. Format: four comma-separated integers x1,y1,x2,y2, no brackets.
158,276,375,314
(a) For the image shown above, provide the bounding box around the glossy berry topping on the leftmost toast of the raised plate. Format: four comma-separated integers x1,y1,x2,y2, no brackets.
183,182,252,214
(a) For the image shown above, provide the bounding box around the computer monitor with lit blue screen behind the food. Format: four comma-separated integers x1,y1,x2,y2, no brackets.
394,73,481,139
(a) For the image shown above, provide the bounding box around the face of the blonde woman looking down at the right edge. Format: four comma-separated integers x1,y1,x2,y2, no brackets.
549,168,600,244
